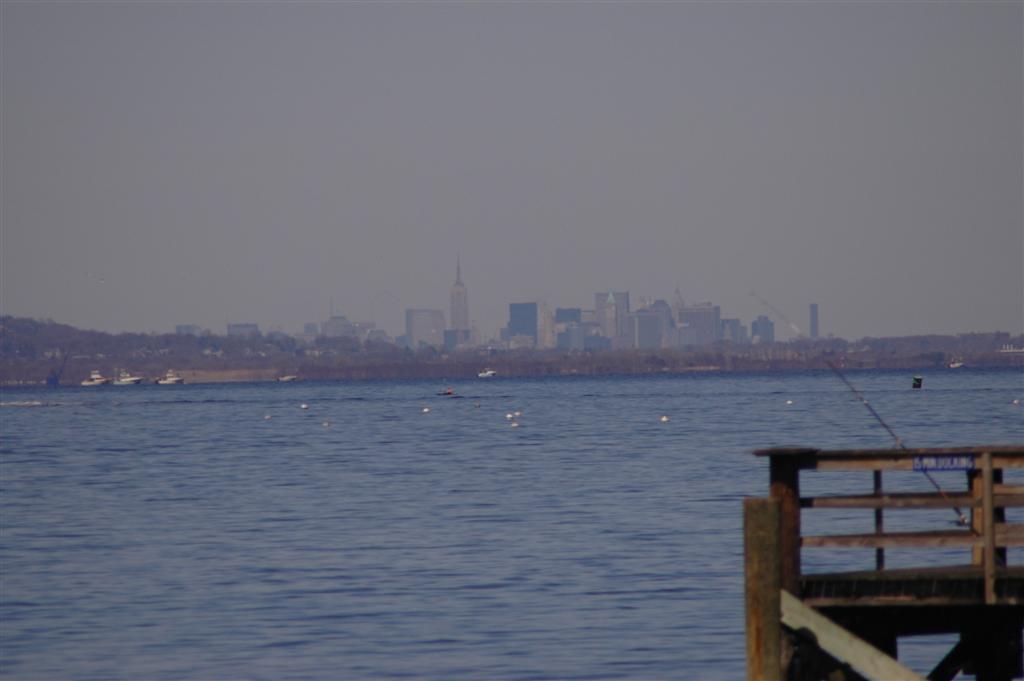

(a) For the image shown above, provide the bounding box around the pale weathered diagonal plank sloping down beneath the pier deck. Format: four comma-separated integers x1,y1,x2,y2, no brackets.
780,591,926,681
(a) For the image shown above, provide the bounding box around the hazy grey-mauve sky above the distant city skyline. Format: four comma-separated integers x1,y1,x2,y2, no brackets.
0,0,1024,338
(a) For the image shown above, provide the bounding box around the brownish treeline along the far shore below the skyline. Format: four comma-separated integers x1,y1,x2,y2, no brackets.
0,316,1024,385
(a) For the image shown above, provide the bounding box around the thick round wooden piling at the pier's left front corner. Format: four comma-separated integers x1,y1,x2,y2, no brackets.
743,499,782,681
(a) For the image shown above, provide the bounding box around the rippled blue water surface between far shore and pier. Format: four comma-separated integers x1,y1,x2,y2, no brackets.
0,369,1024,680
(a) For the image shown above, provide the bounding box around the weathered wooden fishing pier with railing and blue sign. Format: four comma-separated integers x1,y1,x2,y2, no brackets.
743,445,1024,681
